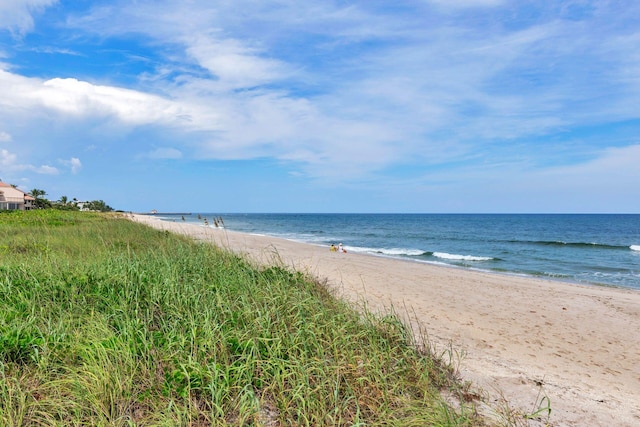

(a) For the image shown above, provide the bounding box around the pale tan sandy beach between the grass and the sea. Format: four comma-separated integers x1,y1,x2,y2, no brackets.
132,215,640,426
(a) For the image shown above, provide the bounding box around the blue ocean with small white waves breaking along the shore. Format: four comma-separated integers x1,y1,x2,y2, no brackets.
157,213,640,290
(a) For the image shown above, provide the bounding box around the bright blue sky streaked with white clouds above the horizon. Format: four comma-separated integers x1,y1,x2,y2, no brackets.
0,0,640,213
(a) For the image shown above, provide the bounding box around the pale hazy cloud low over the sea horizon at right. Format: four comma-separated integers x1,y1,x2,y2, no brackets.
410,144,640,213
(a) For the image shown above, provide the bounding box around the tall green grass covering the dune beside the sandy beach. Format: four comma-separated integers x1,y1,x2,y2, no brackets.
0,210,480,426
